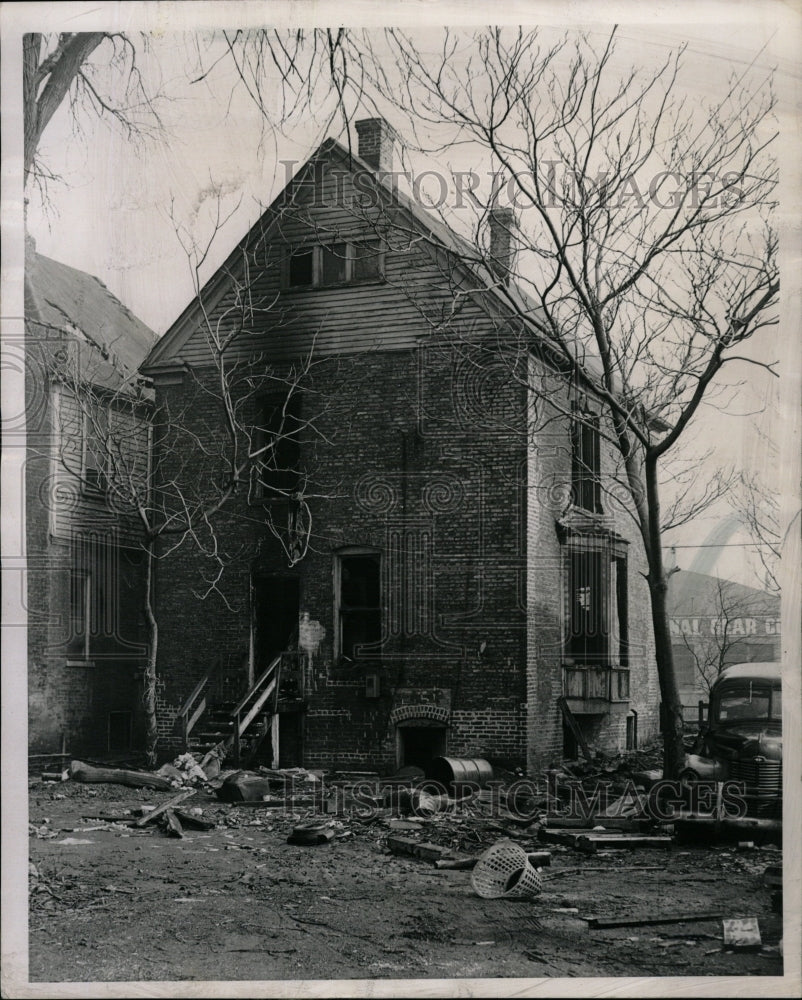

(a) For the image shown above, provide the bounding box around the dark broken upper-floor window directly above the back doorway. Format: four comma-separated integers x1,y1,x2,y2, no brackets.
254,391,302,498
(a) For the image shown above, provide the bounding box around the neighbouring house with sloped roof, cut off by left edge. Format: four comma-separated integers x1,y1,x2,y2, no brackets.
24,241,156,756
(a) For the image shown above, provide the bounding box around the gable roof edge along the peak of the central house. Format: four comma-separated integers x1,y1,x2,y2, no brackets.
142,138,552,372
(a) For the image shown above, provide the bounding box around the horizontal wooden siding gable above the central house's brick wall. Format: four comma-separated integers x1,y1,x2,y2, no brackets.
143,140,544,375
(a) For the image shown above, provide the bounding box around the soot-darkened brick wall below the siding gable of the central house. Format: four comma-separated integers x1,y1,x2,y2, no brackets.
153,349,526,769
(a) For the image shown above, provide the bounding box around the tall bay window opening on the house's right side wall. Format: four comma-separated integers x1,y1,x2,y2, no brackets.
565,543,629,666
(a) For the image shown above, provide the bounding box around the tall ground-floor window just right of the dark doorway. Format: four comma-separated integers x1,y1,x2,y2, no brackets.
336,551,381,660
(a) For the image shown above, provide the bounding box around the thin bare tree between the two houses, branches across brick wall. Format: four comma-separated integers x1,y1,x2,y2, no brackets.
51,205,328,760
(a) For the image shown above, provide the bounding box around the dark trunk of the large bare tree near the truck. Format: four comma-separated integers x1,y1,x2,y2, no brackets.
644,456,685,778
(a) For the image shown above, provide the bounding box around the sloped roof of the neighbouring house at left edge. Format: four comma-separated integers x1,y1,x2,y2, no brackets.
25,251,157,373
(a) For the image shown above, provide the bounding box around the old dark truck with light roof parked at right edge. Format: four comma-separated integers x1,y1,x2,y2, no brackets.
680,663,783,818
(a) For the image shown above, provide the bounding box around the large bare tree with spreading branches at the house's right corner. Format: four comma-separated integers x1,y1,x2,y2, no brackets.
373,21,779,775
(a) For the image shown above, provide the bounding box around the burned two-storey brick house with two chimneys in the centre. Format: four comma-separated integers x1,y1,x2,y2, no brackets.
142,119,659,773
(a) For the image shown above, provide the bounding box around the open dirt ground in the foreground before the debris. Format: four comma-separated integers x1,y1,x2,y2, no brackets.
29,779,783,982
